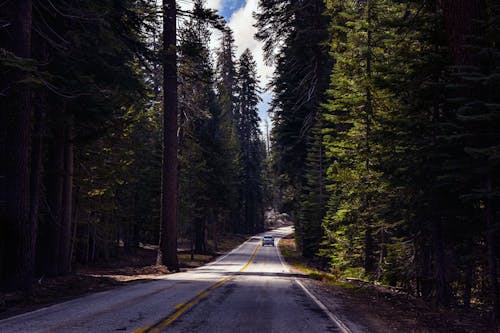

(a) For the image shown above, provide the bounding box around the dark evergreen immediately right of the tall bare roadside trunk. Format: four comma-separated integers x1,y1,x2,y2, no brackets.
179,1,220,253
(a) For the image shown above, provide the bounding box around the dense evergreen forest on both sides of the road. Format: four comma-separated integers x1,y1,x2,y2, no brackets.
0,0,500,320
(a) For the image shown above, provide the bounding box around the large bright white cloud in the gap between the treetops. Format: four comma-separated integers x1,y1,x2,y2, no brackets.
229,0,274,88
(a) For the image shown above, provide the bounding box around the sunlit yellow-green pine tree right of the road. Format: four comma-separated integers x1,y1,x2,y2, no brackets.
324,1,452,286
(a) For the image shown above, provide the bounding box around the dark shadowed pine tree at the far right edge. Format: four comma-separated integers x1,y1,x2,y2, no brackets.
442,1,500,321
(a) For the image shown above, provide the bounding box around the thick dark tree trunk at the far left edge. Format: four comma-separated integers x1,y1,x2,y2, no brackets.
2,0,36,292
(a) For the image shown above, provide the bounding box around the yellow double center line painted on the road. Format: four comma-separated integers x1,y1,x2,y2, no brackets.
132,244,261,333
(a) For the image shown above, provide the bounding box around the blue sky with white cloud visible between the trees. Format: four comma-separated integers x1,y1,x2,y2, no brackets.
179,0,274,134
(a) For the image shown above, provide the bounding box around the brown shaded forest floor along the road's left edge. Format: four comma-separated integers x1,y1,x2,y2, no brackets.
0,235,249,319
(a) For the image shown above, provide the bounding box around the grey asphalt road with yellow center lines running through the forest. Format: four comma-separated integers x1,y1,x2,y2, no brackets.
0,227,349,333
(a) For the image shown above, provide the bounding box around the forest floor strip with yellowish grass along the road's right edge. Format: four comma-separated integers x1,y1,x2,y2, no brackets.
279,238,495,333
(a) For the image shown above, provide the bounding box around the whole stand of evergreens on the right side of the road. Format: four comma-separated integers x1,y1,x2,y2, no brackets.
256,0,500,319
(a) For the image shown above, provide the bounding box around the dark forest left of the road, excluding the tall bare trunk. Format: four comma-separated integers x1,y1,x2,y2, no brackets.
0,0,265,291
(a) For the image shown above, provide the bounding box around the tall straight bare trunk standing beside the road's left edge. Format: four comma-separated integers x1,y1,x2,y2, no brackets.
157,0,179,271
